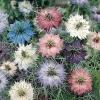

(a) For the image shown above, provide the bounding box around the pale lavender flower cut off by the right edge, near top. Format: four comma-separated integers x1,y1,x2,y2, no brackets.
91,7,100,23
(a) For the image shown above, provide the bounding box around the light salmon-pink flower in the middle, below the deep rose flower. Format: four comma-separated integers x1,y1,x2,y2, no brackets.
39,34,63,57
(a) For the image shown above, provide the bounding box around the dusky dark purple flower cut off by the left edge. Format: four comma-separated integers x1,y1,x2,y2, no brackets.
0,42,13,61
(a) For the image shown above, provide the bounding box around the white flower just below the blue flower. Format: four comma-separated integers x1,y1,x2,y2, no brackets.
15,44,38,70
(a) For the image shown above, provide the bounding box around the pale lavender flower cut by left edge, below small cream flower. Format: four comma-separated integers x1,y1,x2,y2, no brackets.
0,71,8,92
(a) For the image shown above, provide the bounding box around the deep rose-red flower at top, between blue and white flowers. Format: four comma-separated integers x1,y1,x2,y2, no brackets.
36,8,62,31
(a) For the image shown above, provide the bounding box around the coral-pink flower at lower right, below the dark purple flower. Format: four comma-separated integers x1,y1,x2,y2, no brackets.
68,68,92,95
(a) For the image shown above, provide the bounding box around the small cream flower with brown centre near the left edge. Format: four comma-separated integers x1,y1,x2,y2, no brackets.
0,61,17,75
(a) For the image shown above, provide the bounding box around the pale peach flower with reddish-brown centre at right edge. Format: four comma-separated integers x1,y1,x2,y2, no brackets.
87,32,100,50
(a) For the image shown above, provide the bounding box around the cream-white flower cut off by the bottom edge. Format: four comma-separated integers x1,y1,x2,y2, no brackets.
9,81,34,100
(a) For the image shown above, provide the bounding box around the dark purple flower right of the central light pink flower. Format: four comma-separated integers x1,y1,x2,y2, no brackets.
64,40,86,64
